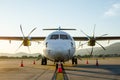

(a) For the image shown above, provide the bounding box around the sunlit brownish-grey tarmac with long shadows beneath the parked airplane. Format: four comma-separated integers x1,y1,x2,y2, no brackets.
0,57,120,80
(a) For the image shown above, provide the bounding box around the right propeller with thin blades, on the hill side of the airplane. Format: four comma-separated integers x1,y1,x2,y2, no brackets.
81,24,108,55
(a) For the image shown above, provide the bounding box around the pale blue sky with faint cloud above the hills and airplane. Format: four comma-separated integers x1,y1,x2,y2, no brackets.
0,0,120,53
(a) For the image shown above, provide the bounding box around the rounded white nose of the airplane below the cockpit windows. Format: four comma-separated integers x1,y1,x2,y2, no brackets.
44,41,74,61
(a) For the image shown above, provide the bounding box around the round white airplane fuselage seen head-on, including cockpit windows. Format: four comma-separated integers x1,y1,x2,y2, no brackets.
42,30,75,62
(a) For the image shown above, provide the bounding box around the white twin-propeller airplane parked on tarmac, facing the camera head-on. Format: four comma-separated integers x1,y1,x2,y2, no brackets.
0,27,120,65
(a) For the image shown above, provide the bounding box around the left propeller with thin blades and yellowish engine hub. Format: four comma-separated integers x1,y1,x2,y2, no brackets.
16,25,36,53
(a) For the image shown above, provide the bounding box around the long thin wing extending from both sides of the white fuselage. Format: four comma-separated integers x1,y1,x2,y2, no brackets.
0,36,120,41
